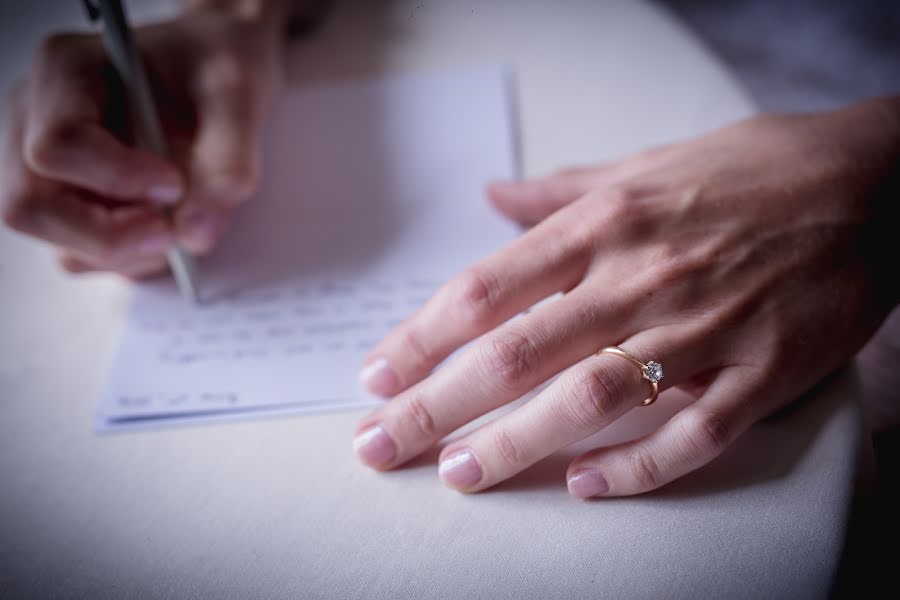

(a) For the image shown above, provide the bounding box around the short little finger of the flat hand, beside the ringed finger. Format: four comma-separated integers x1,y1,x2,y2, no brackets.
566,367,761,498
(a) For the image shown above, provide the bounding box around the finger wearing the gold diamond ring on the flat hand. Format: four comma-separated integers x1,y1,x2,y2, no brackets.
439,326,704,492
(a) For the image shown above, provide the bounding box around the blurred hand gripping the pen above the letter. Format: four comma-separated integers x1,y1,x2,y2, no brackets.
0,3,282,277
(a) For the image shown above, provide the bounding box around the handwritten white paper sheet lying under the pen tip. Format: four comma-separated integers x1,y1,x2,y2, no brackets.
97,68,517,430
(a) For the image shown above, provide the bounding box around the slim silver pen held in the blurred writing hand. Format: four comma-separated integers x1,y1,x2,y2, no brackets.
83,0,200,303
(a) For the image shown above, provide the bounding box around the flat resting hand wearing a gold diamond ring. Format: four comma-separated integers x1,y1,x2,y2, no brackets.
354,101,900,497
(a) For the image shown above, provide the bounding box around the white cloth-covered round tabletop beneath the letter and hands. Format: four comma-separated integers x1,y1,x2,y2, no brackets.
0,0,860,599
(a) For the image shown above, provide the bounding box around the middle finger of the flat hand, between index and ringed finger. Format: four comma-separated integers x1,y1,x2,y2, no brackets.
354,289,631,469
